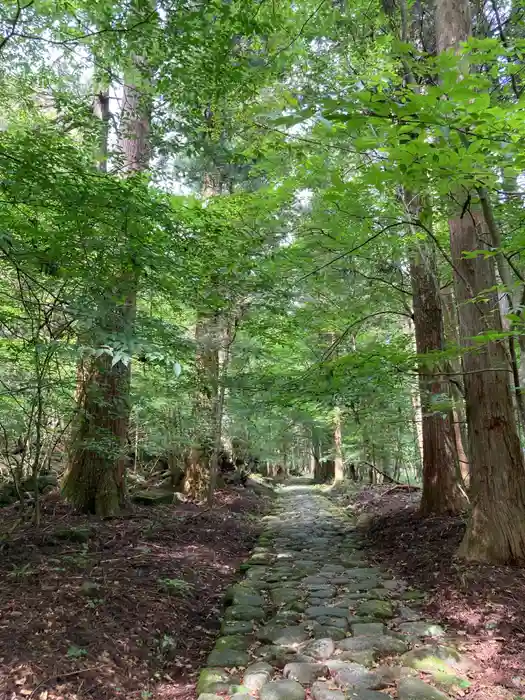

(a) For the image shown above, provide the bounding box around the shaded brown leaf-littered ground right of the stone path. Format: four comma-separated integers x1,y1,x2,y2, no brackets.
332,485,525,700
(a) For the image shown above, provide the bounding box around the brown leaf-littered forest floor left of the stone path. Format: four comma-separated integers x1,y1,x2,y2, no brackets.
0,487,269,700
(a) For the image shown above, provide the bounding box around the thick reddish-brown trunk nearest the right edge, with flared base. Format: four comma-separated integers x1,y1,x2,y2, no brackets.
436,0,525,564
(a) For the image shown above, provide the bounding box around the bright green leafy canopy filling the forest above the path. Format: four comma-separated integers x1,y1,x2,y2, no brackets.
0,0,525,498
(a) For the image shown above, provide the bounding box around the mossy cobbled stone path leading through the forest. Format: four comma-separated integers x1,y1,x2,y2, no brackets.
197,485,470,700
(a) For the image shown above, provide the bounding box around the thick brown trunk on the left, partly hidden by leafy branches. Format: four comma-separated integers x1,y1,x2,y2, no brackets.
63,71,149,517
